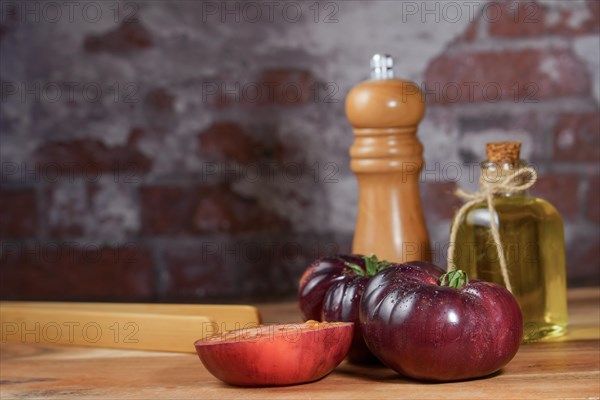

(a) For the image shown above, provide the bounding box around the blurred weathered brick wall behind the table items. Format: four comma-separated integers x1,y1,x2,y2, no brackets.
0,0,600,301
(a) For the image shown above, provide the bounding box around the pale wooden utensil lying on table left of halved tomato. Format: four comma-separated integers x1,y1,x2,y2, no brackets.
0,301,261,352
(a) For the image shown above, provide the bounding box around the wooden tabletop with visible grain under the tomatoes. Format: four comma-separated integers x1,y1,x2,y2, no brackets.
0,288,600,400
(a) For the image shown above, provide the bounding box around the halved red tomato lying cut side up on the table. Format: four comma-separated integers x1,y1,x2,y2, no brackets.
194,320,354,386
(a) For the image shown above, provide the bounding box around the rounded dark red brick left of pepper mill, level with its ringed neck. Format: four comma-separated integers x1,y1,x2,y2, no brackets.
198,122,262,164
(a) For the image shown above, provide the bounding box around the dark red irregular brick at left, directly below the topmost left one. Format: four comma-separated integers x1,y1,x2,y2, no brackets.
35,139,152,175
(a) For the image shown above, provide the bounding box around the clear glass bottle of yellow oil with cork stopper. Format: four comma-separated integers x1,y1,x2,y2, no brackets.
453,142,567,342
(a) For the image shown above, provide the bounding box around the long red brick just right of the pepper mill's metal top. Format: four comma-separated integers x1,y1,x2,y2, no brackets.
425,50,591,104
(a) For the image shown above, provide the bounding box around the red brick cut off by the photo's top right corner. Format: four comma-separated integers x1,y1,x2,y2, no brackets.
488,0,600,38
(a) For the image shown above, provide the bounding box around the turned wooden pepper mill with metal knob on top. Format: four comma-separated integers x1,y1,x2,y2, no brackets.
346,54,431,262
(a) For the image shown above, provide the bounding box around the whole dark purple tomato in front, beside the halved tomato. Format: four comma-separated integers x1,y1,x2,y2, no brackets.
360,263,523,381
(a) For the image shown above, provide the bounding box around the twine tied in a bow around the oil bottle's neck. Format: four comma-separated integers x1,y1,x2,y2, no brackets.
448,167,537,293
